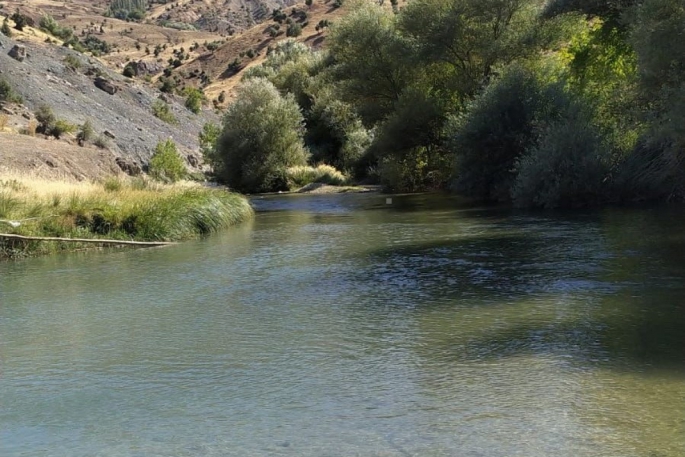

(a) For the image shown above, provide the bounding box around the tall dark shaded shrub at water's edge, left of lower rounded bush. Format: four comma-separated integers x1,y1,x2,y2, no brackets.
445,66,568,201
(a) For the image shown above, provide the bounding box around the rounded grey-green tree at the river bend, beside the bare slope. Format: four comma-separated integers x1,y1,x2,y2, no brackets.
212,78,307,192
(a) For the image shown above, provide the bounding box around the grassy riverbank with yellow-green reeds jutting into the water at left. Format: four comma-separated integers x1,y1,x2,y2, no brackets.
0,175,253,258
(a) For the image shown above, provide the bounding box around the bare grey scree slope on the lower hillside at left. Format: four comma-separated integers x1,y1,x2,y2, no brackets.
0,31,218,172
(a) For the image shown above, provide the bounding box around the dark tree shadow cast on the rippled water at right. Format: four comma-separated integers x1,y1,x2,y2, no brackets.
348,202,685,376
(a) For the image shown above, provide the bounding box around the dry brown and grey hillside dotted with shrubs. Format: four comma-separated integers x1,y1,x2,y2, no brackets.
0,0,404,182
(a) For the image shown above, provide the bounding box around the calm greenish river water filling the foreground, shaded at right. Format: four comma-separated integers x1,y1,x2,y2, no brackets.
0,194,685,457
